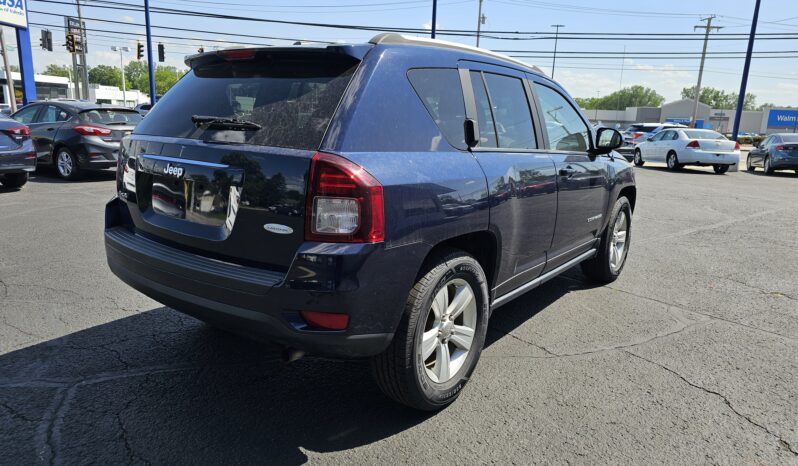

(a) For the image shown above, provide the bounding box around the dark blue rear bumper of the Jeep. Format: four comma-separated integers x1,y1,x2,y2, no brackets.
105,199,417,357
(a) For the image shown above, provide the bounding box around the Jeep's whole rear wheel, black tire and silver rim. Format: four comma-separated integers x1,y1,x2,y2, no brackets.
371,250,489,411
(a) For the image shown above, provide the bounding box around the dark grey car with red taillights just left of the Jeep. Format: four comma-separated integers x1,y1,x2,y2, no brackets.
11,100,142,180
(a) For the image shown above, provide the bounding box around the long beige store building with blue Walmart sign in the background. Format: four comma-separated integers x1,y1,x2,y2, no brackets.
584,99,798,134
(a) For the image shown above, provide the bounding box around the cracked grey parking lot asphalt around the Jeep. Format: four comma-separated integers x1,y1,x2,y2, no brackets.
0,165,798,465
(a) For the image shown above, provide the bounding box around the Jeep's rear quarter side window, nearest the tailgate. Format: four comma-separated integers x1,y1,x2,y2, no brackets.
407,68,466,149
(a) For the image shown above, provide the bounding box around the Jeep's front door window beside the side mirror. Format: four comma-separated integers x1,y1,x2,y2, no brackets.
535,83,590,152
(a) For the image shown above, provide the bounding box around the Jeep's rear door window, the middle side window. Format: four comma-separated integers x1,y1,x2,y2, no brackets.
483,73,537,149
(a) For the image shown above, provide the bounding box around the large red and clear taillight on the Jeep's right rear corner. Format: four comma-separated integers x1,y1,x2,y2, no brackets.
305,152,385,243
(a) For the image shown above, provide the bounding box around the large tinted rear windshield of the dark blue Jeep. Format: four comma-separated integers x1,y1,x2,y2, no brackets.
136,52,359,150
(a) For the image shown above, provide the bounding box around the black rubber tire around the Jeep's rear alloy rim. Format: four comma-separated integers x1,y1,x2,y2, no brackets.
371,250,490,411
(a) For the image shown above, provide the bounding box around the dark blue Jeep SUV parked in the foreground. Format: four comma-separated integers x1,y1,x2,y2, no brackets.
105,34,636,410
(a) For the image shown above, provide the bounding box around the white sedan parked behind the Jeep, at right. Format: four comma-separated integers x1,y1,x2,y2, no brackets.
634,128,740,174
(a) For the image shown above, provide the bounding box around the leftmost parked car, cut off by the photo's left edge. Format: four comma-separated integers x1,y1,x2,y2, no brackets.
0,117,36,188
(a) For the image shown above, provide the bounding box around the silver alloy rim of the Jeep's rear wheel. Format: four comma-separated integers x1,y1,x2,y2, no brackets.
418,278,477,383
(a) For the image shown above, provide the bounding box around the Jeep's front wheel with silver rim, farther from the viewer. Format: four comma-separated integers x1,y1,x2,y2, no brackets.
581,197,632,283
